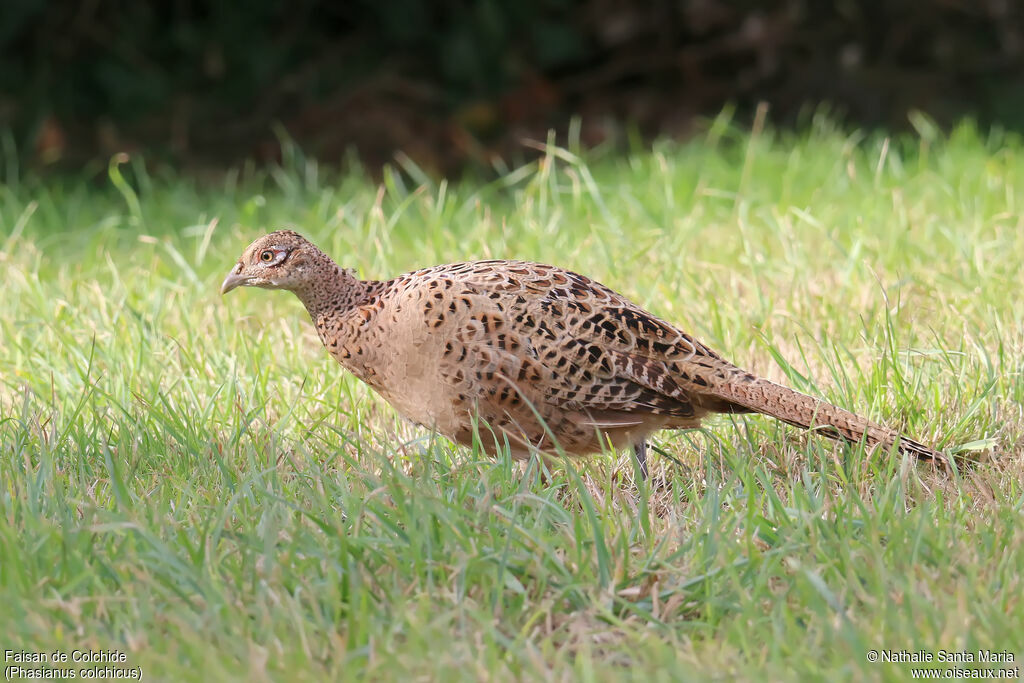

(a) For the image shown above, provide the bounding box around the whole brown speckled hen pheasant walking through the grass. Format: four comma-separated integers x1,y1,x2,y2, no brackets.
220,230,948,476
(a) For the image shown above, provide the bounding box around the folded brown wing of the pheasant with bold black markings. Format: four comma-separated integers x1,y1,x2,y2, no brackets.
432,261,742,426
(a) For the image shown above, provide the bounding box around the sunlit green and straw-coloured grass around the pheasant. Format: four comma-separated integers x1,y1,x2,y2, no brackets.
0,114,1024,680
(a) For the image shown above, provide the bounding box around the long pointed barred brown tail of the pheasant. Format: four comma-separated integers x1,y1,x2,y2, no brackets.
715,374,949,470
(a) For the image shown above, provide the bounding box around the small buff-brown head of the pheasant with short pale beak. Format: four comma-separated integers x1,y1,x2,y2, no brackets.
220,230,325,294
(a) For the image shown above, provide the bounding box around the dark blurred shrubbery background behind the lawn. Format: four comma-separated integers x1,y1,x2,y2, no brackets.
0,0,1024,174
